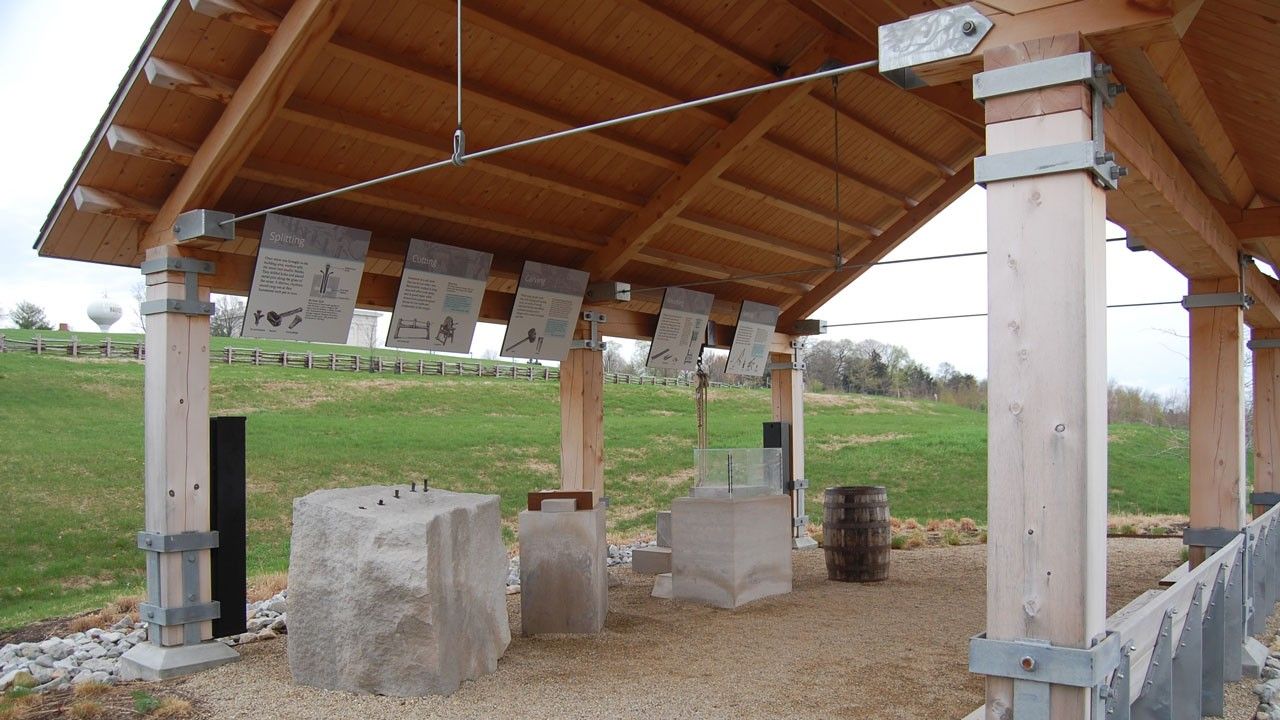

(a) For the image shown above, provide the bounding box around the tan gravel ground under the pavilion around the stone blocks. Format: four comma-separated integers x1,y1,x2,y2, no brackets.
175,539,1182,720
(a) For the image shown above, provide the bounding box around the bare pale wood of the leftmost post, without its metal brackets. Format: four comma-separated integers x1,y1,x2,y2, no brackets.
142,265,212,646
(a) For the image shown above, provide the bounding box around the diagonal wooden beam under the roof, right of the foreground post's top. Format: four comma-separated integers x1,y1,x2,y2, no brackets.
1098,41,1257,208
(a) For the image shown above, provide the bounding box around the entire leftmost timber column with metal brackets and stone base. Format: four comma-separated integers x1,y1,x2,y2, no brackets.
122,249,241,680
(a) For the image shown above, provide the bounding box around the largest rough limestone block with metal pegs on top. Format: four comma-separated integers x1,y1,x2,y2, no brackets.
288,487,511,697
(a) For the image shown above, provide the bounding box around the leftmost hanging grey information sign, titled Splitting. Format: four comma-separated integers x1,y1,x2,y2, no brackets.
242,215,369,343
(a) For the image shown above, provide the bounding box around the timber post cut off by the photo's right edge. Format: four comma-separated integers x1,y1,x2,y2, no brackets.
1249,328,1280,518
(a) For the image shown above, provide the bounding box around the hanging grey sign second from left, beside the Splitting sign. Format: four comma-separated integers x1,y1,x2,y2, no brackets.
387,240,493,352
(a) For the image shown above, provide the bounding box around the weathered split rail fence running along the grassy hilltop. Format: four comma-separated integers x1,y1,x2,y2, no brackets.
0,334,733,387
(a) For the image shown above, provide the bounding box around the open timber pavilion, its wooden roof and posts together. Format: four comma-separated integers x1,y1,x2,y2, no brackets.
36,0,1280,719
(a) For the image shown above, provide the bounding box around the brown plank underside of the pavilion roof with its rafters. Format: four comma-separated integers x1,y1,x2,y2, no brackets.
27,0,1280,329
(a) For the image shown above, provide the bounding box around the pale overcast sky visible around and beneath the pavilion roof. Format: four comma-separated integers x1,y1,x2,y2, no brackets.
0,0,1188,393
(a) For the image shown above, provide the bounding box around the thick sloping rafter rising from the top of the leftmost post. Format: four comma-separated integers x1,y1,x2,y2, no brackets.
142,0,351,249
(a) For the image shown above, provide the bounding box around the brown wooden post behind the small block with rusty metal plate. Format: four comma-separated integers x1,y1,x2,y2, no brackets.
559,332,604,500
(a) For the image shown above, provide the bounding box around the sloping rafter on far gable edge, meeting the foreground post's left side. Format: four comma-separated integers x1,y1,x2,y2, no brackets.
778,163,973,328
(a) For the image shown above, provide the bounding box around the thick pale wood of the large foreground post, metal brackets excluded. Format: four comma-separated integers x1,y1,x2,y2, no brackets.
984,35,1107,720
